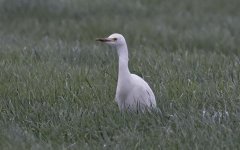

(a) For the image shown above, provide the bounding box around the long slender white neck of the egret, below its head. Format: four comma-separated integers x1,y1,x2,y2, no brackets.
117,44,130,80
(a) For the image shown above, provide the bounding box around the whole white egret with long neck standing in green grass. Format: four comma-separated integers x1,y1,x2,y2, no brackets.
96,33,156,111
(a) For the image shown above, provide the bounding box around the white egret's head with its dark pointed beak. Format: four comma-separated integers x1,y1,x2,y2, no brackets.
96,33,126,47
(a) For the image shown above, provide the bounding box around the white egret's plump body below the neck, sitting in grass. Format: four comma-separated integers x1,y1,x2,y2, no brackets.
115,74,156,111
